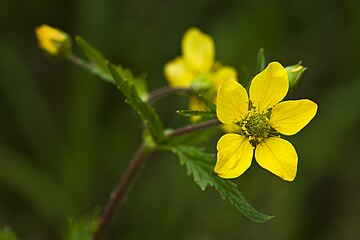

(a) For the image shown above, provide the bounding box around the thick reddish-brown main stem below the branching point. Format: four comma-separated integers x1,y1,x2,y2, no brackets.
93,143,151,240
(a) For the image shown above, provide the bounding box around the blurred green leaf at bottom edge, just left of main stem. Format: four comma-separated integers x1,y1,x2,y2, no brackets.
64,217,99,240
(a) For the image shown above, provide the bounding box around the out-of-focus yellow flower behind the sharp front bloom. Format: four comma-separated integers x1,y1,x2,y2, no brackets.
164,27,236,114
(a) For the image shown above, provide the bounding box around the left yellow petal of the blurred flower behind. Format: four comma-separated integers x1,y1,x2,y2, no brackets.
164,57,195,87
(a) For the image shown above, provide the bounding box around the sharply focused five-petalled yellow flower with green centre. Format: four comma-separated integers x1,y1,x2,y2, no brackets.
215,62,317,181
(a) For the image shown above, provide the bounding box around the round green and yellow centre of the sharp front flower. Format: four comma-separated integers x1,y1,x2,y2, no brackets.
240,109,271,147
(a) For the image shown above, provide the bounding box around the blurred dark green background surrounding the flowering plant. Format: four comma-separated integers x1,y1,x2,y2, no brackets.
0,0,360,240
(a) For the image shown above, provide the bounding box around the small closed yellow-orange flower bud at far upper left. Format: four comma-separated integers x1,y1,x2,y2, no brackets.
35,24,71,56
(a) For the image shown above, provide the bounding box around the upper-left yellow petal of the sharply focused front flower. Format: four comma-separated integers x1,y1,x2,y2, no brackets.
216,80,249,124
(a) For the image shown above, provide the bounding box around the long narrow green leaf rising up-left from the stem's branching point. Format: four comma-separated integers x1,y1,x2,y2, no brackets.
108,63,164,143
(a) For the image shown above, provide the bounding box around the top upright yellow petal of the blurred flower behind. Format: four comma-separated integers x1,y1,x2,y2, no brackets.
181,28,215,72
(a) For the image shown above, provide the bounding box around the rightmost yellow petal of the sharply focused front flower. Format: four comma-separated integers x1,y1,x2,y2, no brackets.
270,99,317,135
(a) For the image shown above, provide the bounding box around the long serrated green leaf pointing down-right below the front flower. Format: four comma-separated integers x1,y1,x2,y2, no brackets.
170,145,273,222
